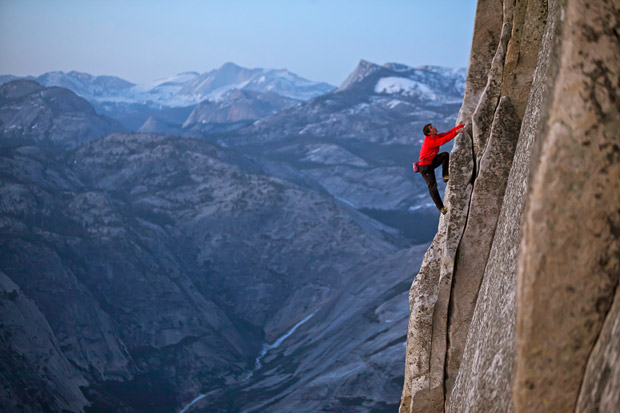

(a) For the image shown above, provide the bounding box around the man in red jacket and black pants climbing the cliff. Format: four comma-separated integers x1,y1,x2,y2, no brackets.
418,123,467,215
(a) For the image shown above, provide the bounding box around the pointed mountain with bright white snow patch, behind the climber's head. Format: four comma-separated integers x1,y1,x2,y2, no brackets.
225,60,466,146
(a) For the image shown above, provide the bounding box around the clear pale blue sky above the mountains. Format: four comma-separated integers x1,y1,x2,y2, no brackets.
0,0,476,85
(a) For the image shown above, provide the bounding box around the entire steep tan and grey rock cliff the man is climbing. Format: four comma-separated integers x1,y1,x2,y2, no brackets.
400,0,620,412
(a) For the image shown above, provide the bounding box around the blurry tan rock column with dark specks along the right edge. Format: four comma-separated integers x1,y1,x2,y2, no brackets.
514,0,620,411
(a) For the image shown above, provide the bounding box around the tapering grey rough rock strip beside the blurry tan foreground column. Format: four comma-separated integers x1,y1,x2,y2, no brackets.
449,2,558,412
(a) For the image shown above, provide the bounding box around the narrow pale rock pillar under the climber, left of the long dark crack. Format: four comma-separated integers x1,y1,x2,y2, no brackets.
400,125,473,413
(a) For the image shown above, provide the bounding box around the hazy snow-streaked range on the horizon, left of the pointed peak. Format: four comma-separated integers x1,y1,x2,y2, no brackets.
0,63,335,131
